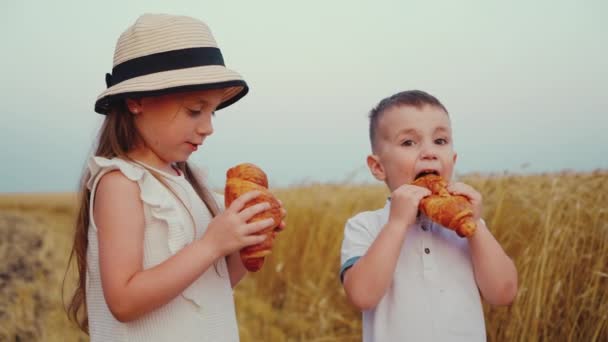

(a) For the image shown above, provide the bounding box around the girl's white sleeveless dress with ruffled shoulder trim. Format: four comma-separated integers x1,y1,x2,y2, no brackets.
86,157,239,342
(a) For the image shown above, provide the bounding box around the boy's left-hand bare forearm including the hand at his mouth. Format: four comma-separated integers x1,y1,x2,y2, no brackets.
343,184,431,310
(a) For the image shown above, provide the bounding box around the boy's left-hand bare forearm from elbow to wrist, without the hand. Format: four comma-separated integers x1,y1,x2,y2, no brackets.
343,222,407,310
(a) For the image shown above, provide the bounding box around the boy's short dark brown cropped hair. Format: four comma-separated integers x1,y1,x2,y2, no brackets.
369,90,448,151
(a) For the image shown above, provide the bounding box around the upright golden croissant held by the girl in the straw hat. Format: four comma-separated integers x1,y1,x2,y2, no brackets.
224,163,281,272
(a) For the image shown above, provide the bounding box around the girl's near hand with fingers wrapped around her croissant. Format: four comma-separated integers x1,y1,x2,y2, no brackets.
201,191,274,257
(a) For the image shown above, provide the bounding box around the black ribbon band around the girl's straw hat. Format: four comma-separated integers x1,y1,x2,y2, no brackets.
106,47,224,88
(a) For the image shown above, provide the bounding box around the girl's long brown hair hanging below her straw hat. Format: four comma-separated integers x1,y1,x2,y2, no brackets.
62,102,219,334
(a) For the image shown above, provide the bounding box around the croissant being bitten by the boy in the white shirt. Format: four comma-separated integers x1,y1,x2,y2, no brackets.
412,174,477,237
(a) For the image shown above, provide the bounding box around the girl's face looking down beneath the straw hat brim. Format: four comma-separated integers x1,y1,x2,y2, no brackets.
127,89,224,172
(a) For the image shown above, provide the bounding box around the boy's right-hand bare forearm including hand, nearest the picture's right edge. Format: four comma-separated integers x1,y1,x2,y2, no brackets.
448,183,517,305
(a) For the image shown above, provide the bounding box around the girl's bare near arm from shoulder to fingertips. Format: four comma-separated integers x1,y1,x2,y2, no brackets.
93,171,272,322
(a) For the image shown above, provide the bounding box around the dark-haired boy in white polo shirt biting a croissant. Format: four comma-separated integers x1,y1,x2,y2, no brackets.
340,91,517,342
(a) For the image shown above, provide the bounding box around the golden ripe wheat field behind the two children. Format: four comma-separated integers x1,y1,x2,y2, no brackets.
0,171,608,341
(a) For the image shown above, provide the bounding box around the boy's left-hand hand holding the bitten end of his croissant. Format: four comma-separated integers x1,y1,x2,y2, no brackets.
388,184,431,228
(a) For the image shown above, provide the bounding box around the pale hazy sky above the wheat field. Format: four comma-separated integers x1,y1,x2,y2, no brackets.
0,0,608,192
